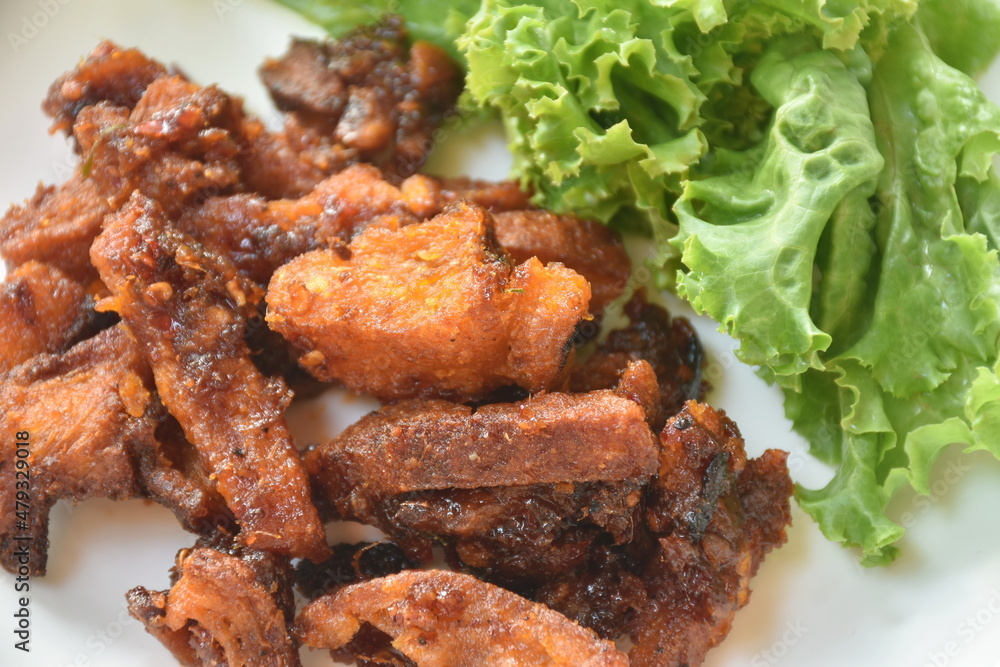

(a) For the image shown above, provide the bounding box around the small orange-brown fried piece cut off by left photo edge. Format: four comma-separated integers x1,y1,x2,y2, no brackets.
0,261,94,375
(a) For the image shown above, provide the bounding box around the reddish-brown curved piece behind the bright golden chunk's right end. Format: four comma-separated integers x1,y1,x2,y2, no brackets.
494,210,632,314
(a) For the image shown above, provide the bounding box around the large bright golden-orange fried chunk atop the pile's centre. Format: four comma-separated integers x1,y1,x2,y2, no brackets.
267,205,590,400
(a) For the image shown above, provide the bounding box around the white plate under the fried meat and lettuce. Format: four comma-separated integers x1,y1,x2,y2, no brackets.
0,0,1000,667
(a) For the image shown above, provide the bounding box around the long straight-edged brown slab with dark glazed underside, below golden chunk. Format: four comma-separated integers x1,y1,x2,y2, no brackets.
305,380,657,583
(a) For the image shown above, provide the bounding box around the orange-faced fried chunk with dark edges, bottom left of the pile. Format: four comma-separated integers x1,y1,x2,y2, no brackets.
126,545,300,667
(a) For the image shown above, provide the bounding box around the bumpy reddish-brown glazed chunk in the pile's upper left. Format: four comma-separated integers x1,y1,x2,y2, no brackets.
73,76,243,214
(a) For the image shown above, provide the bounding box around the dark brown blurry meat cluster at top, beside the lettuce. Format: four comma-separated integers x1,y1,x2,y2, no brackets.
261,17,461,185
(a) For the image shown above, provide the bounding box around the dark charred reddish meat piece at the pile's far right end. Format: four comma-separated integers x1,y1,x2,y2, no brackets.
534,401,792,667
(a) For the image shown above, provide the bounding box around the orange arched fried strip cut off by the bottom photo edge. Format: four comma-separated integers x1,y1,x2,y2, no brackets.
295,570,628,667
